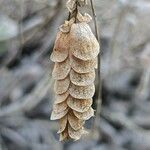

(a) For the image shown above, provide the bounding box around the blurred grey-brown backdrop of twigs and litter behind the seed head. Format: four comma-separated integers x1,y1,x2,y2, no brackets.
0,0,150,150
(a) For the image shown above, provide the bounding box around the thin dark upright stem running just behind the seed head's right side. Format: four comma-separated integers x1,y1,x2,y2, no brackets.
90,0,102,128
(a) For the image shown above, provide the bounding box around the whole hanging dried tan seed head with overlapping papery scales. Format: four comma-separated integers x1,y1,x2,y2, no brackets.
51,0,100,141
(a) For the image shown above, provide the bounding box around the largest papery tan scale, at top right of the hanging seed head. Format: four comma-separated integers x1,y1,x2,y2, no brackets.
70,22,100,60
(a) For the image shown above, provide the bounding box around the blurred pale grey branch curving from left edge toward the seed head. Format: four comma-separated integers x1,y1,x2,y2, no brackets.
0,76,52,117
